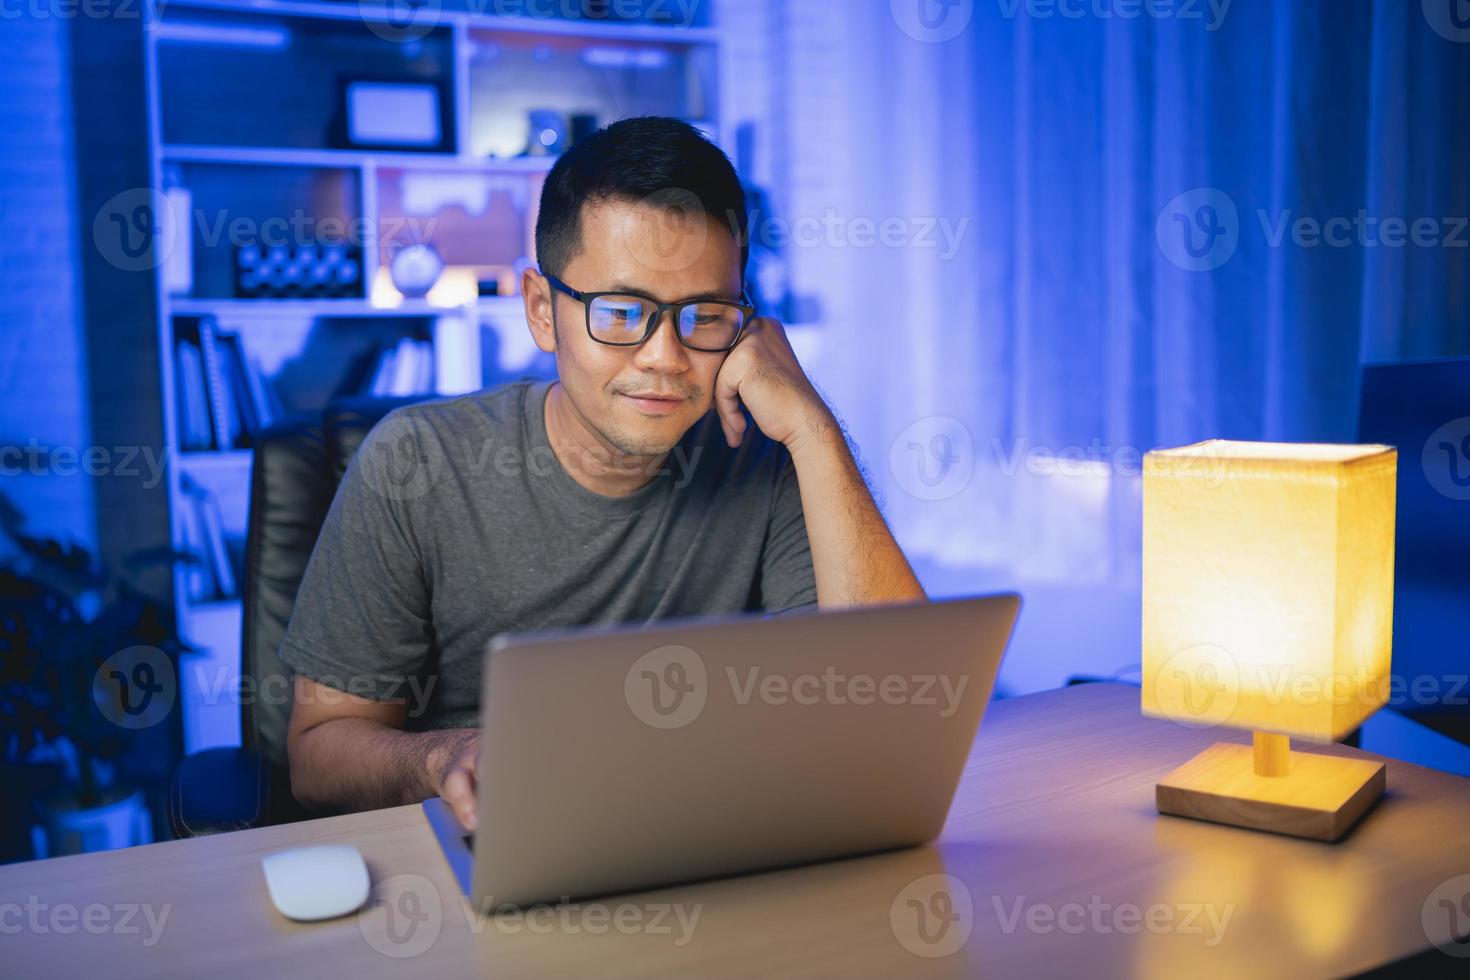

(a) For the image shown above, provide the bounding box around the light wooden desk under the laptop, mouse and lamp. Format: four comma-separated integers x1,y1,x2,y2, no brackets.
0,685,1470,980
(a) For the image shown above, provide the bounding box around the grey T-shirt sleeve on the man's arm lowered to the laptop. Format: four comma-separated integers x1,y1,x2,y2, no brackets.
281,410,442,701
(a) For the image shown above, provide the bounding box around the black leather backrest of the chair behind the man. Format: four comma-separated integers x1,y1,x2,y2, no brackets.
241,398,420,787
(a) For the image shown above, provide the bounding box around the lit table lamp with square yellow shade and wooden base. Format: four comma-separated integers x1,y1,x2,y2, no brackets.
1142,439,1398,840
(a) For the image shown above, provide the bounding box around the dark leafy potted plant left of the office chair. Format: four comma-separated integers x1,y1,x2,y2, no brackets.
0,497,188,858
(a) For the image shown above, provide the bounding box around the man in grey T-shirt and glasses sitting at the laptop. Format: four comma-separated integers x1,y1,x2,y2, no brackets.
281,118,925,830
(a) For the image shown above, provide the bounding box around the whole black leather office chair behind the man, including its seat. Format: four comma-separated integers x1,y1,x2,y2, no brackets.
169,398,420,837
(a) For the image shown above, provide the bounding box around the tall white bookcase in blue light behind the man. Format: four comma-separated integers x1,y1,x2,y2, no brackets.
132,0,723,752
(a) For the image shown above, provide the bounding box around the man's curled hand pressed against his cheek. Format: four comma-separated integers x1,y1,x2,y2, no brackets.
714,316,836,450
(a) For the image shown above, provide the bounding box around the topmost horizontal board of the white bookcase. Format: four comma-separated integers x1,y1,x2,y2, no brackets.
158,0,717,44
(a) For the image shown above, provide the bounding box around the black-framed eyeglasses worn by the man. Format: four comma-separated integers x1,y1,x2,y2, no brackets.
542,273,756,351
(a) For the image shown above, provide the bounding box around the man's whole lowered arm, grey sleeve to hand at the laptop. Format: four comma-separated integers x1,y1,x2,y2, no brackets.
281,410,479,821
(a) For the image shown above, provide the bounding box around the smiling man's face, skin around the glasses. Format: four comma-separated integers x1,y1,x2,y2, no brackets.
526,200,741,457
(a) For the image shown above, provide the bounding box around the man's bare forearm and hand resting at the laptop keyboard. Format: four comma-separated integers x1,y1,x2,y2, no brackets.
287,674,479,830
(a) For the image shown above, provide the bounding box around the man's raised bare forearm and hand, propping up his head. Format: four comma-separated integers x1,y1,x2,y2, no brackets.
714,317,928,608
